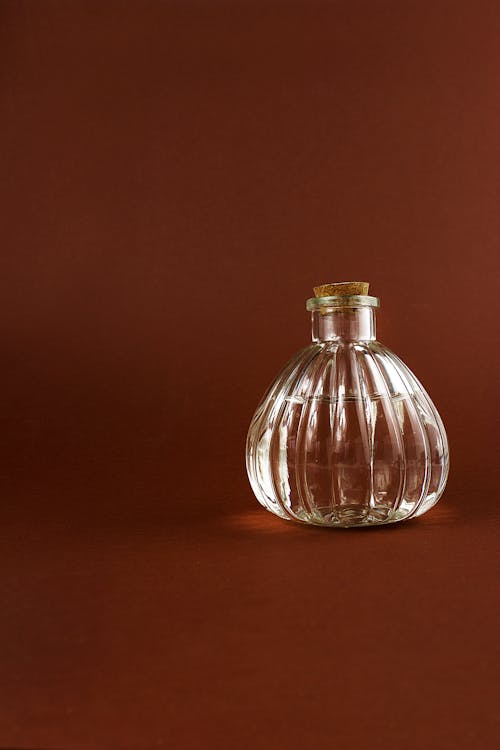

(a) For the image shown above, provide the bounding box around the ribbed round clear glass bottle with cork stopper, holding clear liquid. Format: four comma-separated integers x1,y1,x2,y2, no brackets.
246,282,448,527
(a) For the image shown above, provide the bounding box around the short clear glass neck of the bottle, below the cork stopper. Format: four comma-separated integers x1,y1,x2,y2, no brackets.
312,307,376,341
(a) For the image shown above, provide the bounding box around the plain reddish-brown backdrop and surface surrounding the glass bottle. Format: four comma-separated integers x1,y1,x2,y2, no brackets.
0,0,500,750
